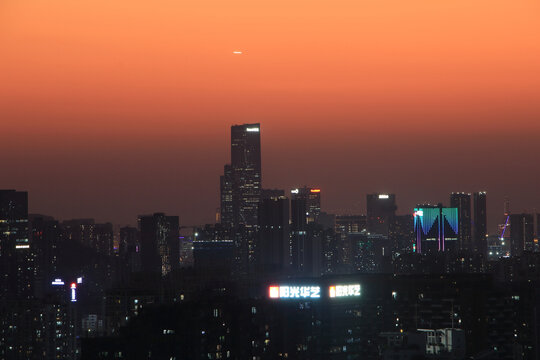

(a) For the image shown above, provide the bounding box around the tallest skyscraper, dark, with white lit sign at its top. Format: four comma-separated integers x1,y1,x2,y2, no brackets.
231,124,262,228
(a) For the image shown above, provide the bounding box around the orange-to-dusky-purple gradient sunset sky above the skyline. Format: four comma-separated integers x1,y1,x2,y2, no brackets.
0,0,540,230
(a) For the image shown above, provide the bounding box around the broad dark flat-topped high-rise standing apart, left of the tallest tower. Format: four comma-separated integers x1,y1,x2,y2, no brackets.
139,213,180,276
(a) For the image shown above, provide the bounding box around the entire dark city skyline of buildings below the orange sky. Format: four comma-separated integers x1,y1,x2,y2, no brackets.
0,124,540,360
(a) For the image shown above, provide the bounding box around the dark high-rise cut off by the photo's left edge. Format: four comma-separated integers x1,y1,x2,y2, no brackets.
0,190,34,299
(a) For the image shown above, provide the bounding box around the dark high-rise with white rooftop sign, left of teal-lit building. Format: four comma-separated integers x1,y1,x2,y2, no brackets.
366,194,397,236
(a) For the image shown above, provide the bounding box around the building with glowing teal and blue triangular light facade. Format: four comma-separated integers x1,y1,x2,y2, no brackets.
414,205,459,253
